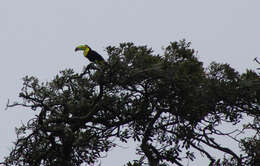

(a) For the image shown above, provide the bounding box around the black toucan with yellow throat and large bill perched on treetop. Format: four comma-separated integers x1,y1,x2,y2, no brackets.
75,45,106,65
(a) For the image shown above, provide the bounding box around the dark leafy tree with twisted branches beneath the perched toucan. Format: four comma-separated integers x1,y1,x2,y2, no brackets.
2,40,260,166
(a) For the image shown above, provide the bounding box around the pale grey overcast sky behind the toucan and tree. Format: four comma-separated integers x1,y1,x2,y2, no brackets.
0,0,260,166
